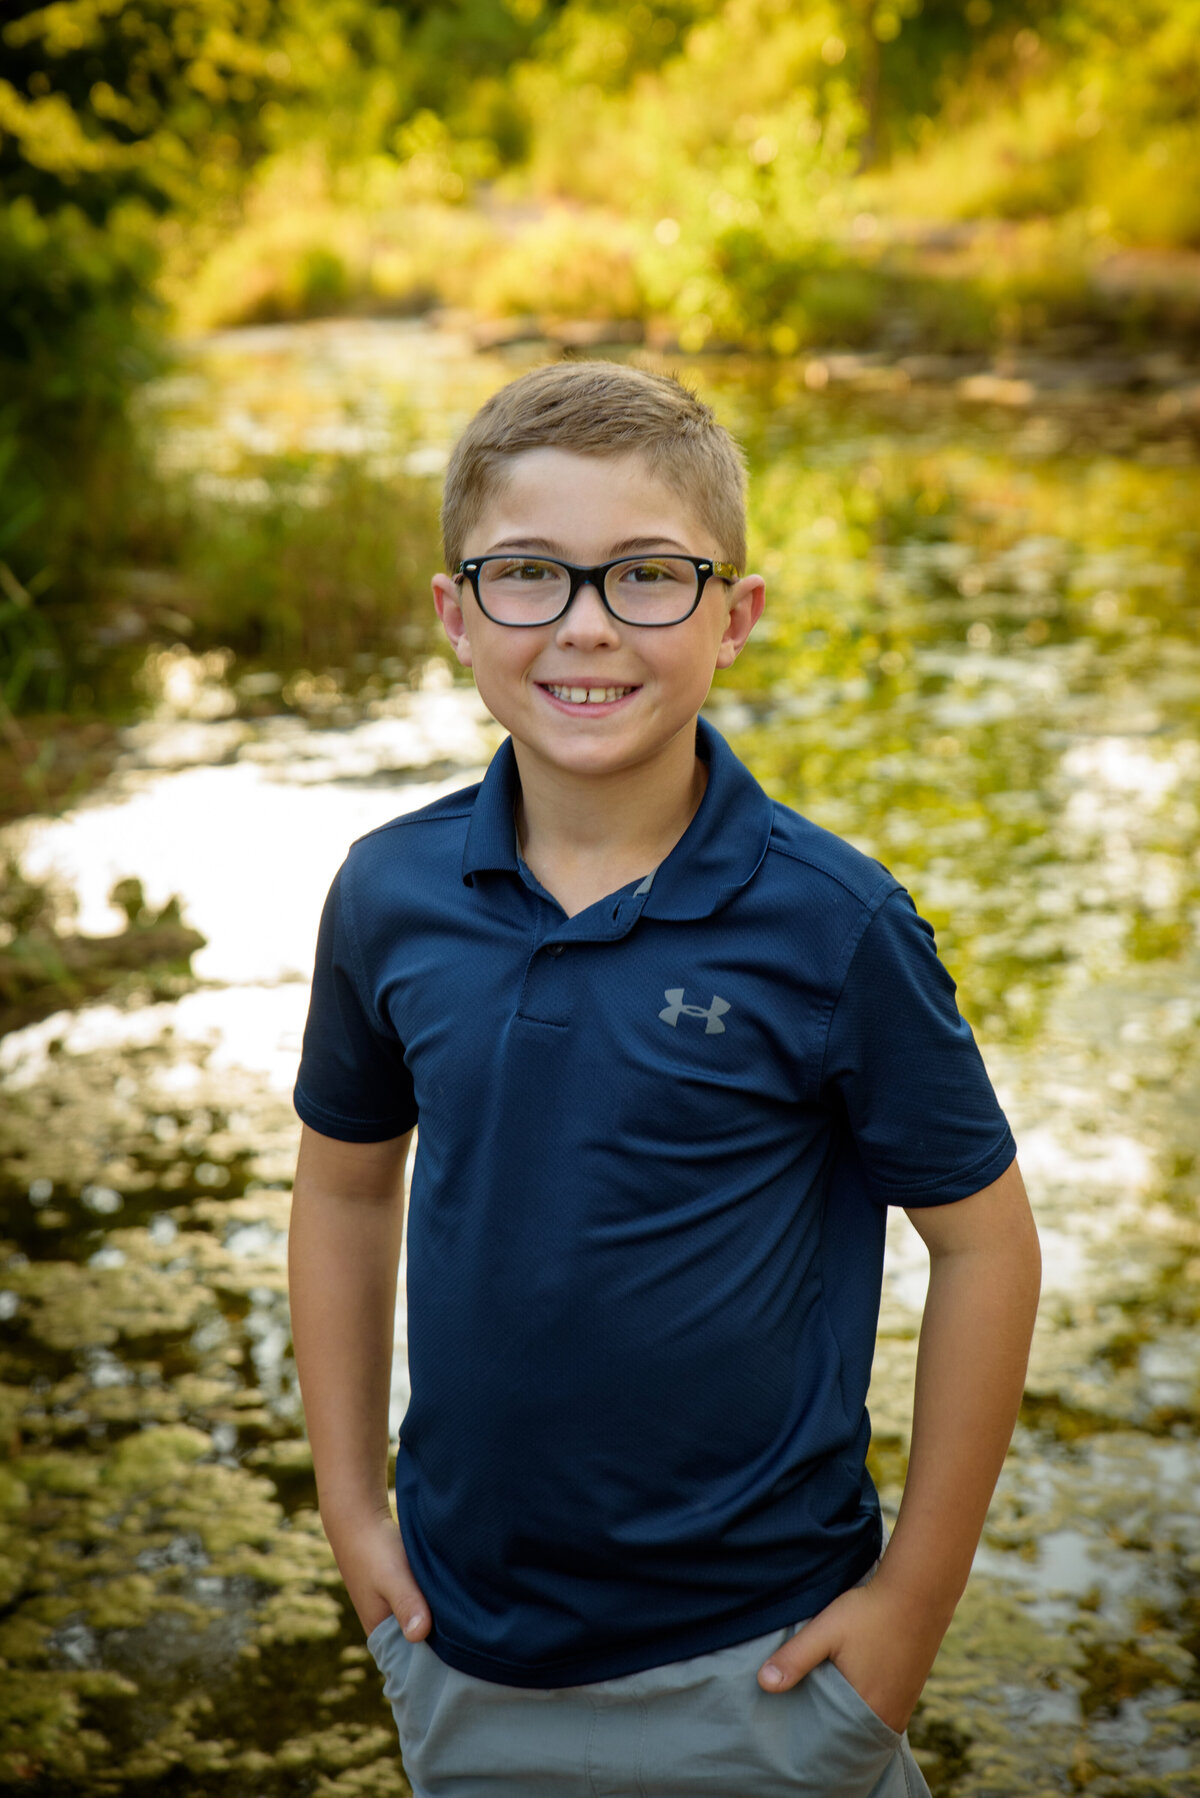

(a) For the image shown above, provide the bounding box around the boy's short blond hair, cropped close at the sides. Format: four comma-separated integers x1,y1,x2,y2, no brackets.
441,361,747,570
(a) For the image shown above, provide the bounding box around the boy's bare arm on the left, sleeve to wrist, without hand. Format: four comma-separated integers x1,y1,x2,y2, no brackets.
288,1138,407,1523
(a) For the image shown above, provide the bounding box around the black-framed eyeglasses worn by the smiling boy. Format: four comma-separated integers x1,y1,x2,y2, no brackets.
455,554,738,629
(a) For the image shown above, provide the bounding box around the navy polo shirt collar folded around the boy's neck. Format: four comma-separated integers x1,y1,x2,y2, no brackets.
462,717,772,919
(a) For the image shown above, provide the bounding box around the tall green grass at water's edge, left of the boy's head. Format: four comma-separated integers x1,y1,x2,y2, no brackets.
0,411,449,740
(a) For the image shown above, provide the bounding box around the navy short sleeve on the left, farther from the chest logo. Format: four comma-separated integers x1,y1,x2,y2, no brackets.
293,868,417,1142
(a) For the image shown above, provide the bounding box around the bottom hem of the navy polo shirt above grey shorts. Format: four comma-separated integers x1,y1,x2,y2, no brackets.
426,1519,883,1692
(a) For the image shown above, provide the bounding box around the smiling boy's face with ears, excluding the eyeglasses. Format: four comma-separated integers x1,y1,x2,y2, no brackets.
434,450,763,779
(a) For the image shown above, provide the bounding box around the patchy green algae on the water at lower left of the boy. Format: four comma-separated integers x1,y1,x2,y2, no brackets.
0,1048,407,1798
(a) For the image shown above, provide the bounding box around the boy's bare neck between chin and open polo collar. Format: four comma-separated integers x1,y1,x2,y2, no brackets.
513,730,709,917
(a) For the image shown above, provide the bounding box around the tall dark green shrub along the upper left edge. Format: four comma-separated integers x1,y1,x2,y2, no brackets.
0,0,282,708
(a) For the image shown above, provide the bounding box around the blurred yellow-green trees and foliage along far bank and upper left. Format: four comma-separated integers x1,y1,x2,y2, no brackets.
0,0,1200,710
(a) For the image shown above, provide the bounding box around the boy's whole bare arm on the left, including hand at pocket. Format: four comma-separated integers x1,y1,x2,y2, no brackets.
288,1126,430,1642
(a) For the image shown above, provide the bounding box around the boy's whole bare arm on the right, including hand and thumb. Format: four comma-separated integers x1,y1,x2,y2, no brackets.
759,1162,1042,1730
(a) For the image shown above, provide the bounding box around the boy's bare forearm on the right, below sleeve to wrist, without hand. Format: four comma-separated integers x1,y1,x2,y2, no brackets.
883,1179,1040,1640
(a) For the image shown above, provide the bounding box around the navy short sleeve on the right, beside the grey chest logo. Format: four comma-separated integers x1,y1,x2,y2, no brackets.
822,888,1016,1206
